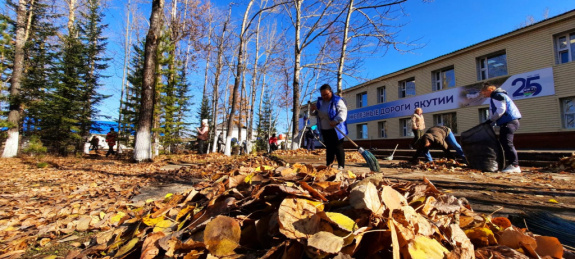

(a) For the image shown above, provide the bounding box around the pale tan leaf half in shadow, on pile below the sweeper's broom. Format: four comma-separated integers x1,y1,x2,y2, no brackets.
349,182,385,215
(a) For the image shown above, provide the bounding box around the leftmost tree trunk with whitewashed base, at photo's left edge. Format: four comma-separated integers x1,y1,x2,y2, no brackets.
2,0,26,157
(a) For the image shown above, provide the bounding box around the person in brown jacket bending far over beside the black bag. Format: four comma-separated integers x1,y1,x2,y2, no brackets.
411,126,465,162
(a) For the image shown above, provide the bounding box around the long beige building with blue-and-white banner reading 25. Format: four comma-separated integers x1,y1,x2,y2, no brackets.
343,10,575,149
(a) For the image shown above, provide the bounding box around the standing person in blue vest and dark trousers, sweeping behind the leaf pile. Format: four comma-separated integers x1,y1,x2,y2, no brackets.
310,84,348,170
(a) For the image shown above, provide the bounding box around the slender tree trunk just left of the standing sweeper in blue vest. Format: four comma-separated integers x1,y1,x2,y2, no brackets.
291,0,301,149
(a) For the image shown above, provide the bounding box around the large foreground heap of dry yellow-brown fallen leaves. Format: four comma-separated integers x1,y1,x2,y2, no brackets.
56,158,563,259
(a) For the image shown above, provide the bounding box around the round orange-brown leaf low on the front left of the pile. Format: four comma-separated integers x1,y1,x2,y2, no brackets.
204,216,242,256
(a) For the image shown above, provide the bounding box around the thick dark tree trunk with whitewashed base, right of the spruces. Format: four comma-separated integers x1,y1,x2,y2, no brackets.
134,0,164,162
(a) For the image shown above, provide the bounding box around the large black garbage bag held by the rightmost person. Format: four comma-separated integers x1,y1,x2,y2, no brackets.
461,124,505,172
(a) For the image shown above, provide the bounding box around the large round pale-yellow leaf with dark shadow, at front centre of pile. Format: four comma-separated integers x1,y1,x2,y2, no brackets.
278,198,323,239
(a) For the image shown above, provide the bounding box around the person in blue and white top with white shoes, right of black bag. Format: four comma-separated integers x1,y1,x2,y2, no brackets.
481,83,521,173
